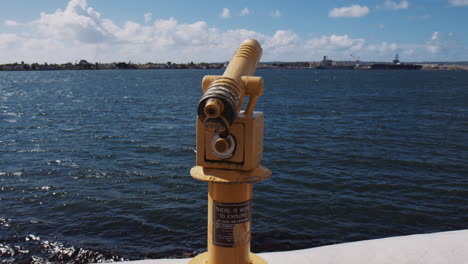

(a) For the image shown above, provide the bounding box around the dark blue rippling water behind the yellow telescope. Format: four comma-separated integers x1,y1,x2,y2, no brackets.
0,70,468,263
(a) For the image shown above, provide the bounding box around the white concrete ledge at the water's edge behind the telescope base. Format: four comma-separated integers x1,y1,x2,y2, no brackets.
116,229,468,264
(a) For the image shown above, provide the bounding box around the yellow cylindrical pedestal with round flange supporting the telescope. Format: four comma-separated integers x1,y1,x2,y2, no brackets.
189,166,271,264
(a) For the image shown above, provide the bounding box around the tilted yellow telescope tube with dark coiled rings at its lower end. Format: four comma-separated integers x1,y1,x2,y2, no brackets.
197,39,262,134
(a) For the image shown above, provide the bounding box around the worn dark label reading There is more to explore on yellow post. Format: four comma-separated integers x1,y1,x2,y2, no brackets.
213,200,252,247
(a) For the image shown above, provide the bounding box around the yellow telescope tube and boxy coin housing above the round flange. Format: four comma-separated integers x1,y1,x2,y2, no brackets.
197,39,264,171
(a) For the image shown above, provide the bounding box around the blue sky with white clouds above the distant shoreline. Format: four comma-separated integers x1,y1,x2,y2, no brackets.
0,0,468,64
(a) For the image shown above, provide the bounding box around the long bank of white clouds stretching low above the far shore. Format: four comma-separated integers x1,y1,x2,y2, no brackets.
0,0,468,63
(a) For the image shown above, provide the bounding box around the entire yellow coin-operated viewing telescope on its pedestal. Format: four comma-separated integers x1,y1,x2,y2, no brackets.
190,39,271,264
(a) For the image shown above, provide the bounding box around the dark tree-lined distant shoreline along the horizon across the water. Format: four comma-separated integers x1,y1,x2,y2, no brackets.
0,60,468,71
